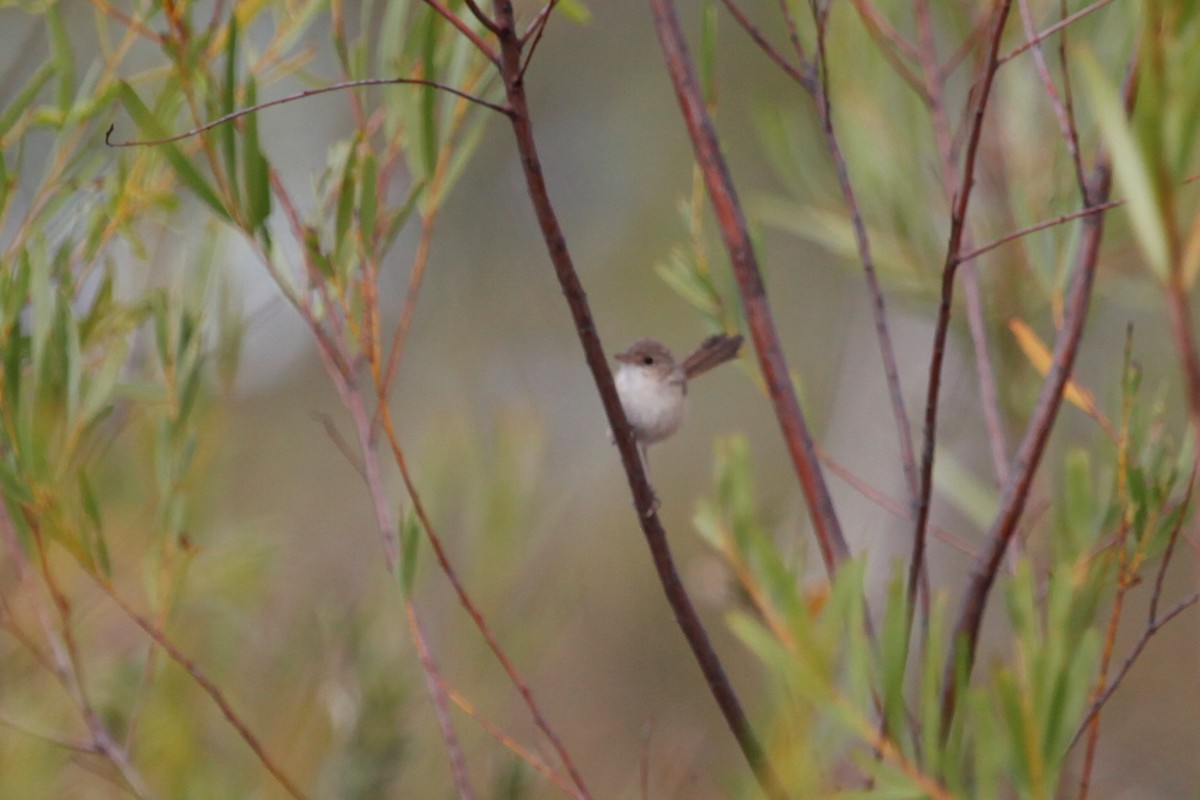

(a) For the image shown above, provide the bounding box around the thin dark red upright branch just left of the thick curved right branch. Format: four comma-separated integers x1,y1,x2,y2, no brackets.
908,0,1012,613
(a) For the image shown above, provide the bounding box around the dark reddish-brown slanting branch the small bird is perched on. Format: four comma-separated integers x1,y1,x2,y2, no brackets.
496,7,786,798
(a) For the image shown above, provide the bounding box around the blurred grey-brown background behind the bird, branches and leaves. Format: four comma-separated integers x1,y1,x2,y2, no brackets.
0,0,1200,800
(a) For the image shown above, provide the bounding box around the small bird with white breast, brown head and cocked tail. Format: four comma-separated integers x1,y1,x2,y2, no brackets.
616,333,742,463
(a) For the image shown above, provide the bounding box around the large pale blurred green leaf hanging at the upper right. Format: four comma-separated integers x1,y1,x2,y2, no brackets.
1079,48,1171,279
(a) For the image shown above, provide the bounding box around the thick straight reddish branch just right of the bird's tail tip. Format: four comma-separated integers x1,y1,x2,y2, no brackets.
649,0,850,573
